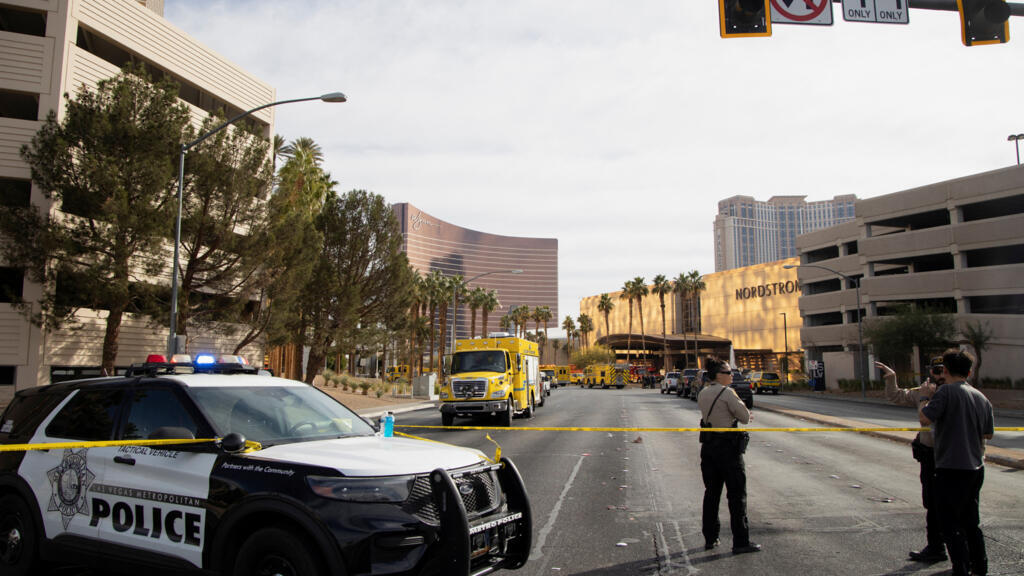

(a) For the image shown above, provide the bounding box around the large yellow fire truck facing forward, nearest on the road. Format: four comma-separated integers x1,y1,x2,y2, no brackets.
440,333,544,426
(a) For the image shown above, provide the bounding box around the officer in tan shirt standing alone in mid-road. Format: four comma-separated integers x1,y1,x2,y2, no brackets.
697,356,761,553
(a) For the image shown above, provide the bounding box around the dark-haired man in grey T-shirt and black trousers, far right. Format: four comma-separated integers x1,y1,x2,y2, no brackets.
920,349,995,576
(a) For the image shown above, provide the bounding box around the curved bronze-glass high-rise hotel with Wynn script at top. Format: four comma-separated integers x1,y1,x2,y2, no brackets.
392,203,560,338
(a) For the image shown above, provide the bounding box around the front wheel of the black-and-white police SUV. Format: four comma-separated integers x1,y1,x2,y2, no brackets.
234,528,323,576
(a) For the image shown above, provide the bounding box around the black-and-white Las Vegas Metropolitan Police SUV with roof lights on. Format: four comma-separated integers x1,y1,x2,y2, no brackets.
0,358,531,576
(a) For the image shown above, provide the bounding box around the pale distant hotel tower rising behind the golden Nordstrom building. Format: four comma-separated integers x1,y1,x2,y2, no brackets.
715,195,857,272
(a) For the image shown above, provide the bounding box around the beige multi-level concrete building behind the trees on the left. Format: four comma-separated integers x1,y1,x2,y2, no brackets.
0,0,276,393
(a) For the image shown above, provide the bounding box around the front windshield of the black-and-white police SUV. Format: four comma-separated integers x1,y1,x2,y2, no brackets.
189,385,374,446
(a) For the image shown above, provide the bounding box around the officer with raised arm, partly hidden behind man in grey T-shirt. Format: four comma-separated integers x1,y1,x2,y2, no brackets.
874,359,946,563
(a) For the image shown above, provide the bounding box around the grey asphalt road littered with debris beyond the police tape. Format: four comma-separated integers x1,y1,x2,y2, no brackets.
41,387,1024,576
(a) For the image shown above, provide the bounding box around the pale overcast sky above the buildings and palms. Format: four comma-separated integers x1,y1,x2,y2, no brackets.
164,0,1024,335
